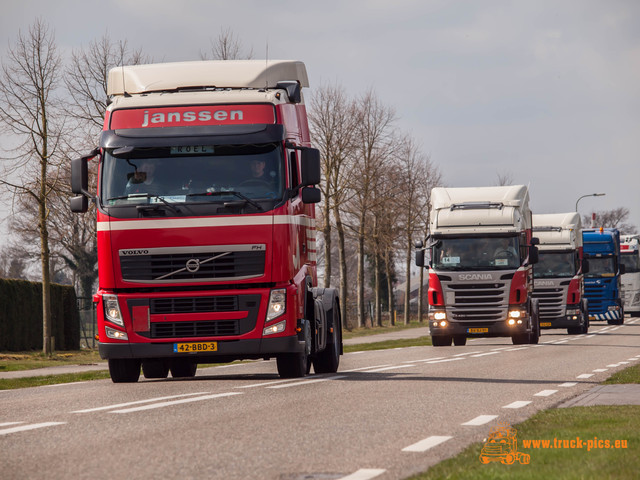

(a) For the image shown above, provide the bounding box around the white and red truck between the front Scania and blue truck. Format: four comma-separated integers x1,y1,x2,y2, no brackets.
533,212,589,334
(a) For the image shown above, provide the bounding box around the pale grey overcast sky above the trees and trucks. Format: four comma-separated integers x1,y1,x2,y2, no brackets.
0,0,640,232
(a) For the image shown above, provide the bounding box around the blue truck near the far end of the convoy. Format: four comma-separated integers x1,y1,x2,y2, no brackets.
582,228,625,325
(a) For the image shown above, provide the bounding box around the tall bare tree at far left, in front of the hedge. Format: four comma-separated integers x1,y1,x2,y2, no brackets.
0,19,63,354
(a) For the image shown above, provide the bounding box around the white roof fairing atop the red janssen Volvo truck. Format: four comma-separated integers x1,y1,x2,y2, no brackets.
107,60,309,95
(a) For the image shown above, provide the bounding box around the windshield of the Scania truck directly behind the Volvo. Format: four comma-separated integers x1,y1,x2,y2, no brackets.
431,237,520,270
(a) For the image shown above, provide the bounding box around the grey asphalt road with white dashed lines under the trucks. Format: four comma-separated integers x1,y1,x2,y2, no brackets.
0,318,640,480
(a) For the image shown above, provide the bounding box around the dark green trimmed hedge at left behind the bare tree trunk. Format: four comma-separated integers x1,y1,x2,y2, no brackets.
0,279,80,352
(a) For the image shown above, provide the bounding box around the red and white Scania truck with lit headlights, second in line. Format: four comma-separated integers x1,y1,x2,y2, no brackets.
416,185,540,346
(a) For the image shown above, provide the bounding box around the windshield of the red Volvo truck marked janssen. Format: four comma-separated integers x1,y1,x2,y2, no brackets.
101,143,285,206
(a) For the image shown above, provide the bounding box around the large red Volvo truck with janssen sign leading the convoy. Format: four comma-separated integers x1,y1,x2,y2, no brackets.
71,60,342,382
